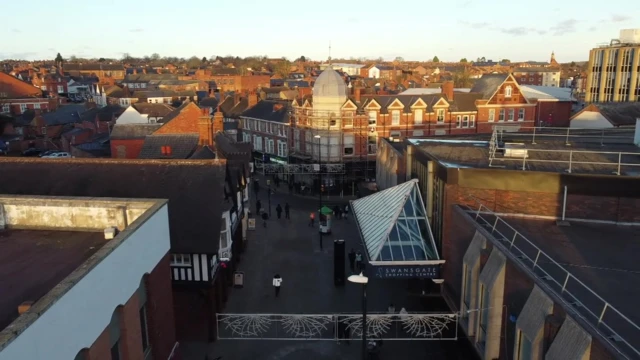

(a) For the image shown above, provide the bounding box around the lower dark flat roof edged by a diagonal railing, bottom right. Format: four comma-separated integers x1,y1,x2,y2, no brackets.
462,209,640,358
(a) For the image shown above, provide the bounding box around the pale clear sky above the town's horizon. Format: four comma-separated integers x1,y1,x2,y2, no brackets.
0,0,640,62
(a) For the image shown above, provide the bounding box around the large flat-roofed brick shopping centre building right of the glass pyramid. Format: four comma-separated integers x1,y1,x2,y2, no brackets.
378,133,640,360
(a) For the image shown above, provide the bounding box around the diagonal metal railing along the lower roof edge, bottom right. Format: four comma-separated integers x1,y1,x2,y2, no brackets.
465,204,640,359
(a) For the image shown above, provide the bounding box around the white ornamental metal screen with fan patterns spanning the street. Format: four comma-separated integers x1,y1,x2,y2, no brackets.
217,313,458,341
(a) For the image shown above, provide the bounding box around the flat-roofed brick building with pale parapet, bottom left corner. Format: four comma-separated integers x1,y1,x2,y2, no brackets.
0,194,179,360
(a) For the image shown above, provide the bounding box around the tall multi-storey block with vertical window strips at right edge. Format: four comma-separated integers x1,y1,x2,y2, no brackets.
585,29,640,102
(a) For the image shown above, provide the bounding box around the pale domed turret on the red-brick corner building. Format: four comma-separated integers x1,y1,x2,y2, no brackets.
313,65,349,117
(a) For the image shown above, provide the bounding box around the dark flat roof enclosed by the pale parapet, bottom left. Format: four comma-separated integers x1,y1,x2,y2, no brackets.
0,229,108,331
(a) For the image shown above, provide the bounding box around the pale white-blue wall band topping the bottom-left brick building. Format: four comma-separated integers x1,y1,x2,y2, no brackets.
0,205,170,360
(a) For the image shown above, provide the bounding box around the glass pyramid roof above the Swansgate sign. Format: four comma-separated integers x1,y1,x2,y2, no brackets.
351,179,439,262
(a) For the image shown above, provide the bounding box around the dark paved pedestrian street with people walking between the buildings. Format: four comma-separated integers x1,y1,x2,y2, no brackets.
182,184,470,360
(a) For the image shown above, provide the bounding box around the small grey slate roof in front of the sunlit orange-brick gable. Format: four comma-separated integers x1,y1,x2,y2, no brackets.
138,134,200,159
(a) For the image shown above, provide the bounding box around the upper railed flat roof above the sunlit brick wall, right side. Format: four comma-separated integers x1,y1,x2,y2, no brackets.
409,132,640,176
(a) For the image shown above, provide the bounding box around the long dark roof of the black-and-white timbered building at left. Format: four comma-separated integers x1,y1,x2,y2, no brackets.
0,158,226,254
